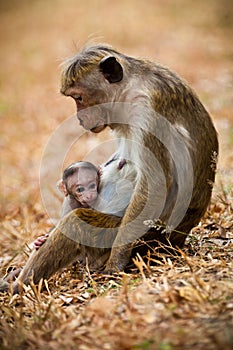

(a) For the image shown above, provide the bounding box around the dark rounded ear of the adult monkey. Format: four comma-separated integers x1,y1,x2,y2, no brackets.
100,56,123,84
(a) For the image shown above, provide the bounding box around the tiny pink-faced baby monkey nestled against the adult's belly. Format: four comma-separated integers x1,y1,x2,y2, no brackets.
34,161,100,250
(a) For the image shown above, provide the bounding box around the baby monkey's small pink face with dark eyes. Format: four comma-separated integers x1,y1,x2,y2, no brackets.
67,168,99,208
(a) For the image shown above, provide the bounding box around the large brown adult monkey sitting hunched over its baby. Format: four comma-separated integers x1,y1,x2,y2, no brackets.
0,45,218,292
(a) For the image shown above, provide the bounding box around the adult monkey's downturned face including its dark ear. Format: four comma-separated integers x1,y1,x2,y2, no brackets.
61,52,123,133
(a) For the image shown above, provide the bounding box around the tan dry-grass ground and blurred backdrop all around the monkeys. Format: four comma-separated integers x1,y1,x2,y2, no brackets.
0,0,233,350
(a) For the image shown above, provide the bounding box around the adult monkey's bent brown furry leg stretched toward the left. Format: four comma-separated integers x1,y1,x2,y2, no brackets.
0,209,121,293
